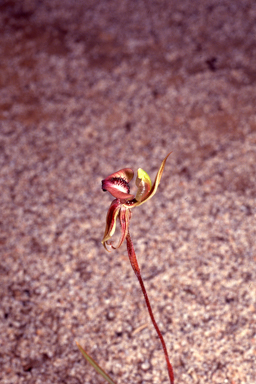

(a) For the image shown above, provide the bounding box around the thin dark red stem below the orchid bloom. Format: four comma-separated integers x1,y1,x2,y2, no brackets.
126,232,174,384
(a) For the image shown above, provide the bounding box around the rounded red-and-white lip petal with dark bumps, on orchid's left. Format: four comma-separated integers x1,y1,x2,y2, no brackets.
102,168,134,200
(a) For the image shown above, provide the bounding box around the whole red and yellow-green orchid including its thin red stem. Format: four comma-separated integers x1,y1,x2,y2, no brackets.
102,152,174,384
